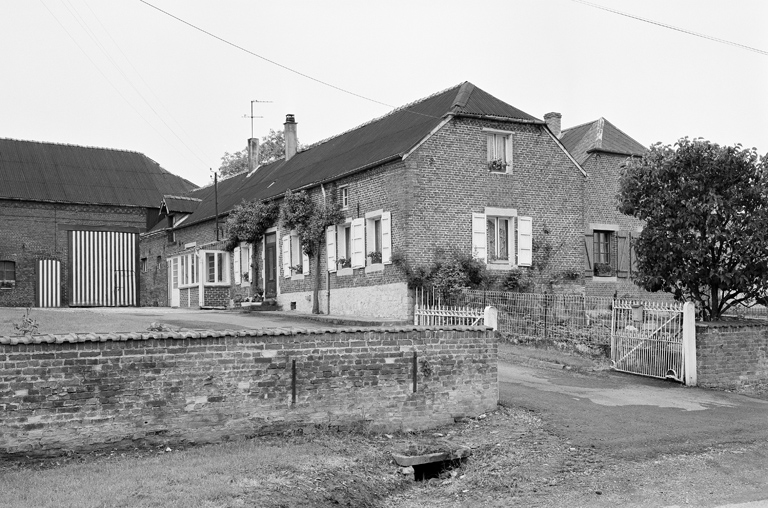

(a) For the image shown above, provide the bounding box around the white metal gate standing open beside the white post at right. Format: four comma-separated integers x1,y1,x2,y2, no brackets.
611,300,685,382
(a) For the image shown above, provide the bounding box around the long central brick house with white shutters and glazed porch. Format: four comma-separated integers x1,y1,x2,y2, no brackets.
141,82,586,318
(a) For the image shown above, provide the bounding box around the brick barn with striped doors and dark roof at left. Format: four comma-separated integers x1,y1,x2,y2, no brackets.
0,139,195,307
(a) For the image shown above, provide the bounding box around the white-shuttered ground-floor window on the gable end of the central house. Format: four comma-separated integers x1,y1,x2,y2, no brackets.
472,207,533,270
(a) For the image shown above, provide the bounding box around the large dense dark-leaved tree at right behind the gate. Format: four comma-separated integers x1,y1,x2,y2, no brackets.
618,138,768,320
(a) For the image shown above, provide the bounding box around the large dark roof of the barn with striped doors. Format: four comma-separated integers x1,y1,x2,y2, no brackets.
0,139,196,208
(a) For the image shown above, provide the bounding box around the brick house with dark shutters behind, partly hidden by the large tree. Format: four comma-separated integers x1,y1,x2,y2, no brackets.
544,113,664,299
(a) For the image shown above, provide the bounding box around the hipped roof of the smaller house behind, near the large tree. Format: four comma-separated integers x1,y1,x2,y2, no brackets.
560,118,646,164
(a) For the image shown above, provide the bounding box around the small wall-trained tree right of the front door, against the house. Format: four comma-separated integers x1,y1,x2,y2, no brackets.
280,190,343,314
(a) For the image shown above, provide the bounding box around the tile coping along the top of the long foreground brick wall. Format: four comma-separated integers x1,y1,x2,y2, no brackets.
0,325,493,346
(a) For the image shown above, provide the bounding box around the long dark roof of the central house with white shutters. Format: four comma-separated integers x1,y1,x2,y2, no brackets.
181,82,544,227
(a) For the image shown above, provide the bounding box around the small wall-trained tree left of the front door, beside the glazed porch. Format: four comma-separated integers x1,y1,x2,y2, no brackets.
226,201,279,295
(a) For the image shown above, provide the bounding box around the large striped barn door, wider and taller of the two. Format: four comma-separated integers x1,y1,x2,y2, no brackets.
69,231,139,307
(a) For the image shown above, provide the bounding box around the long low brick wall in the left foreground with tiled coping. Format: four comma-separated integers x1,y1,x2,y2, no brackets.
0,327,498,457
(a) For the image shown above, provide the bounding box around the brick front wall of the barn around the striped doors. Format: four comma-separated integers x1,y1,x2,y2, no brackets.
0,200,147,307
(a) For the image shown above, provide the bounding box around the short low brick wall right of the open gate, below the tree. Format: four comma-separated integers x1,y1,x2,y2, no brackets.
696,321,768,397
